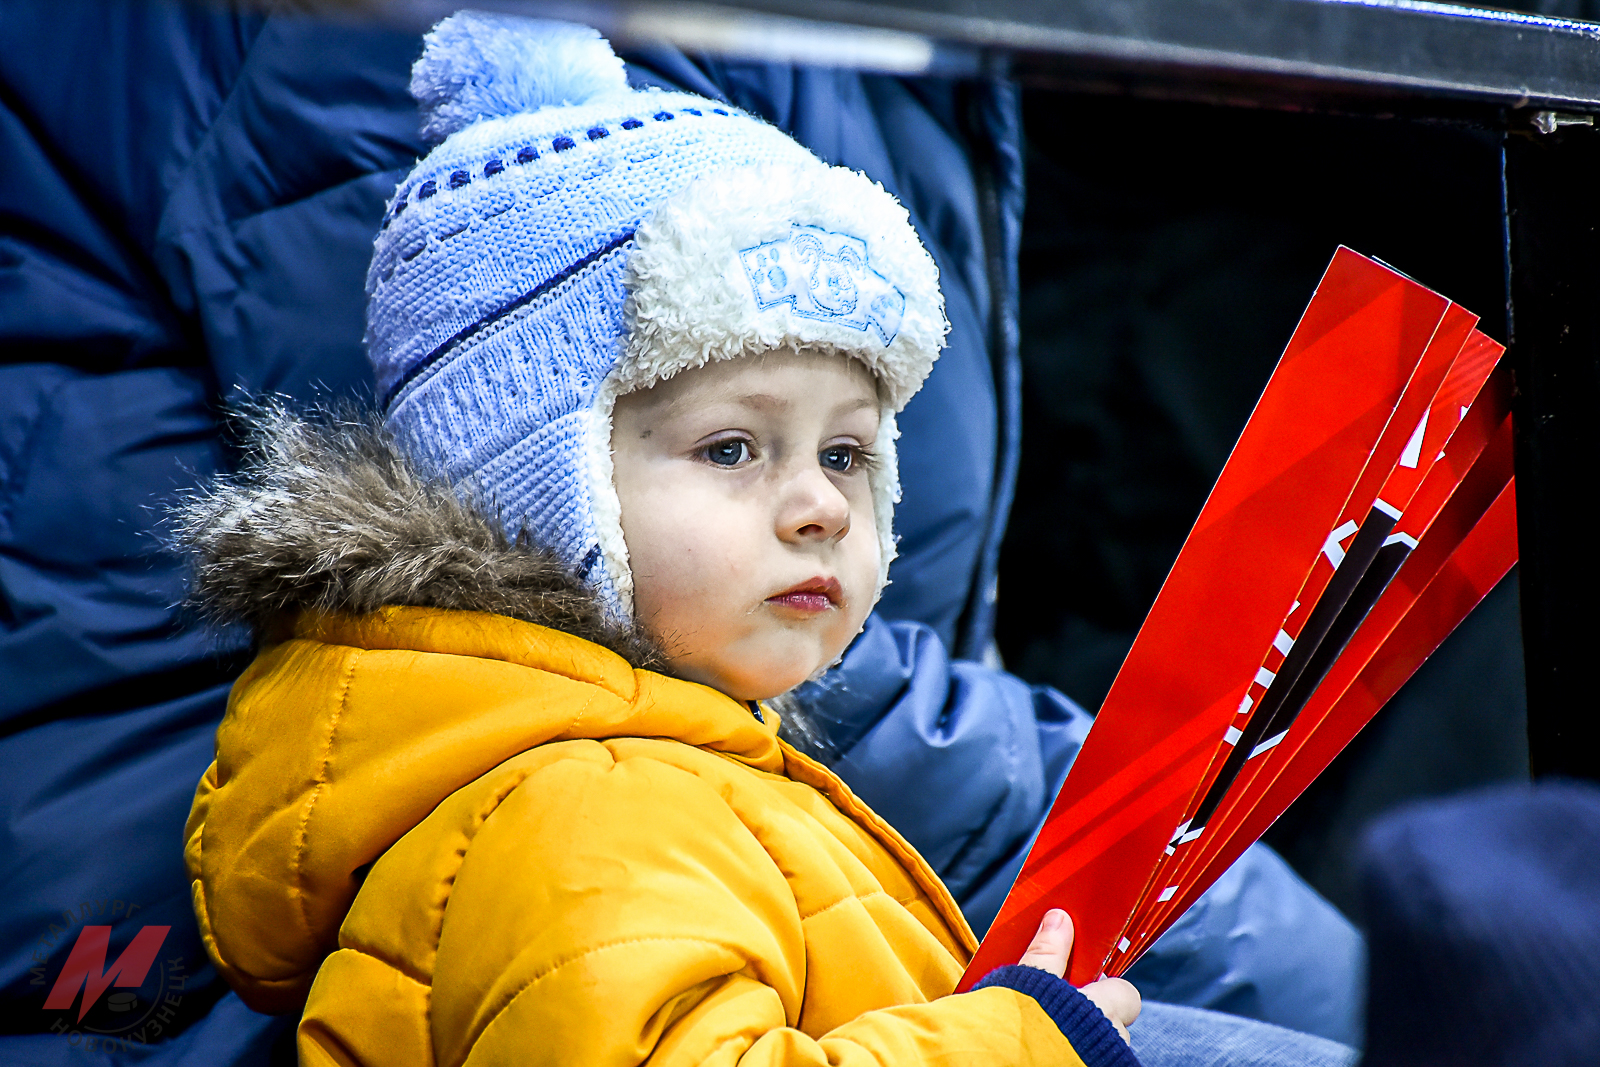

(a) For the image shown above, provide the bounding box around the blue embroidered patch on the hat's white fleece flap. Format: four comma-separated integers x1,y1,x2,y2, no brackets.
739,226,906,347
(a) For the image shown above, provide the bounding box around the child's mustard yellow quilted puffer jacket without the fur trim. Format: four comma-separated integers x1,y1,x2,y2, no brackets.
187,608,1083,1067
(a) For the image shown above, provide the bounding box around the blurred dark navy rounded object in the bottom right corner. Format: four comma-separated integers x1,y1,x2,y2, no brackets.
1362,782,1600,1067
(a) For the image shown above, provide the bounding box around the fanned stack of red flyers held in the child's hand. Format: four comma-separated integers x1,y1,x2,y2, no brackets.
962,248,1517,989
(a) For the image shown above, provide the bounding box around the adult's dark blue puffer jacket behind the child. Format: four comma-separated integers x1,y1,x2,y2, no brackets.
0,0,1360,1067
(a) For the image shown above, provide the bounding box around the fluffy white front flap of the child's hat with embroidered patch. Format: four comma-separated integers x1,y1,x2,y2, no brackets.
614,163,949,411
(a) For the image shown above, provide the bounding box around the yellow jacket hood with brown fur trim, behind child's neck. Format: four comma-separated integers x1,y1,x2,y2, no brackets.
176,410,796,1011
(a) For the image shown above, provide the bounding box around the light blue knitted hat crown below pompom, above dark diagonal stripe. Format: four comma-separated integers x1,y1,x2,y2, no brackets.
366,99,824,400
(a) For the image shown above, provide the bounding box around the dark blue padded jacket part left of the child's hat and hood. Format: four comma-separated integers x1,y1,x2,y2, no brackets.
0,0,421,1065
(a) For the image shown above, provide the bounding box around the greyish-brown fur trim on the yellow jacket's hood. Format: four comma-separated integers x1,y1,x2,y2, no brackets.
173,403,664,669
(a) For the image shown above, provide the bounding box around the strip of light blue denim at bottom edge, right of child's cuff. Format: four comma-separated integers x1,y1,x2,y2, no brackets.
1128,1001,1357,1067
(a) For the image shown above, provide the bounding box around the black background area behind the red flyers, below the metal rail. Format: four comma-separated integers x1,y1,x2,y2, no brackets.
998,90,1526,910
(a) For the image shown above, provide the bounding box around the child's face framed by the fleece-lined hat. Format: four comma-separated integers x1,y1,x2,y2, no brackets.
611,350,880,701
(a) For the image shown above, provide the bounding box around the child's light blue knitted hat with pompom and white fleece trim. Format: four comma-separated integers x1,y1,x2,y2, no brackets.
366,11,947,614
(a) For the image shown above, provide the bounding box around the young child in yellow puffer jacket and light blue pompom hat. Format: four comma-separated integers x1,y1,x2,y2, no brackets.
182,14,1138,1067
